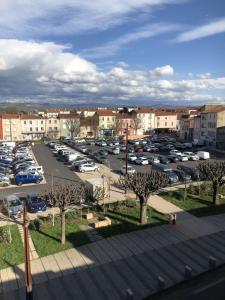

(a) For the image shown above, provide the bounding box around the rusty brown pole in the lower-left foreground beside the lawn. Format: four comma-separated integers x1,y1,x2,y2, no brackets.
23,204,33,300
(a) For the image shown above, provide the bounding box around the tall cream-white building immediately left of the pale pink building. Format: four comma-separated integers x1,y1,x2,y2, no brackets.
135,108,155,135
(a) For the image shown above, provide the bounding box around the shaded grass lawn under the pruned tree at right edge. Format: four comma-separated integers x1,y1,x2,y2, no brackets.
160,189,225,217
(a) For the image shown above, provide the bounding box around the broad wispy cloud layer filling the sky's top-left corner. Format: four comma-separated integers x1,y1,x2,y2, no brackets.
0,0,188,38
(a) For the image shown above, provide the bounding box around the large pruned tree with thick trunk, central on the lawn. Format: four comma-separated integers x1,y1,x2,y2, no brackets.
119,171,169,224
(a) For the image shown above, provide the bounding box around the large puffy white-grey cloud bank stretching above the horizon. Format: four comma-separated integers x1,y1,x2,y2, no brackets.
0,40,225,105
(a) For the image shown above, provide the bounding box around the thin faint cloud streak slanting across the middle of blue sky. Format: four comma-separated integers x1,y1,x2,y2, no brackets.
82,23,181,58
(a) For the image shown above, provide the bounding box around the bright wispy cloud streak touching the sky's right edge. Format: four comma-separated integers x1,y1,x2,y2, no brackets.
175,18,225,42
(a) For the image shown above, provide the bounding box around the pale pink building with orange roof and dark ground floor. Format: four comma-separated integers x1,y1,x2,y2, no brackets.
155,110,177,132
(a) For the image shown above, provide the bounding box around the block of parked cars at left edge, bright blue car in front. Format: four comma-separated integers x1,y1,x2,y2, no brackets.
0,142,44,187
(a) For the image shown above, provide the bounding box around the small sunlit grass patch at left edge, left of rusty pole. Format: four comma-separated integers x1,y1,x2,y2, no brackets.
0,225,24,269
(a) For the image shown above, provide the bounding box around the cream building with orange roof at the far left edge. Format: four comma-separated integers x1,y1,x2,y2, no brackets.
0,114,21,141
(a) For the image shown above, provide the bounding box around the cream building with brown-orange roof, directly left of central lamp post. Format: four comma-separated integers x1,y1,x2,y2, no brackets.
92,110,116,137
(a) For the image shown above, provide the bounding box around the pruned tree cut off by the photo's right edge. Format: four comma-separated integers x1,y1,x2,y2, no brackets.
199,161,225,205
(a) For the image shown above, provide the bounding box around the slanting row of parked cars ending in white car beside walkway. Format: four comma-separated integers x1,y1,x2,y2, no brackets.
47,140,99,172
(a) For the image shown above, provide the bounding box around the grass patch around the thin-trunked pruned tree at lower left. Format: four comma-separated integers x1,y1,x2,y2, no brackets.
29,220,89,256
